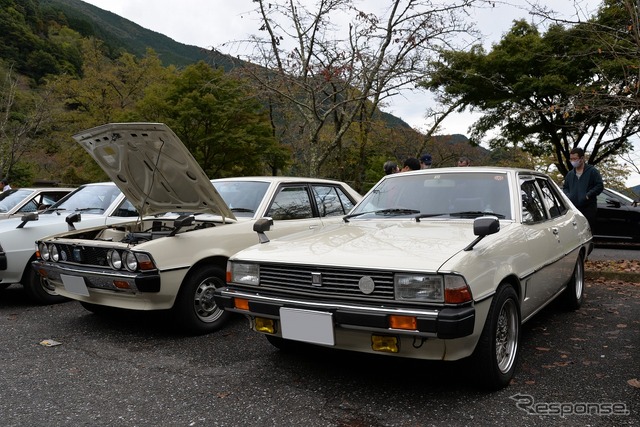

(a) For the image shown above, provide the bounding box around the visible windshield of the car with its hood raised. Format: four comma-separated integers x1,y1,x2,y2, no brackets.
212,181,269,218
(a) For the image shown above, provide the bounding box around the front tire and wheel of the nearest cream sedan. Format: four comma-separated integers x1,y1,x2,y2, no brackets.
473,284,520,390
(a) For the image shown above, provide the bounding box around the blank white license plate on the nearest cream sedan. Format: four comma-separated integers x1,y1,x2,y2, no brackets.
280,307,335,345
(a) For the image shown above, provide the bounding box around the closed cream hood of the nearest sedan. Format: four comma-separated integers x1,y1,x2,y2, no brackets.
234,220,504,271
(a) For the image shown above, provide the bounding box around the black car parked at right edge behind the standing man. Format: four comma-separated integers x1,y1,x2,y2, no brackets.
593,188,640,242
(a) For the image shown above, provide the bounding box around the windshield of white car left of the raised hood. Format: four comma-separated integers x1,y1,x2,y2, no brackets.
44,184,120,214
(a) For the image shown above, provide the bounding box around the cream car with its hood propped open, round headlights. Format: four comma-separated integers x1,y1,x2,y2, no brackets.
33,123,361,334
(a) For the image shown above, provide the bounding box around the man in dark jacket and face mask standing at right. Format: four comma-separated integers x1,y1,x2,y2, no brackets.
562,148,604,230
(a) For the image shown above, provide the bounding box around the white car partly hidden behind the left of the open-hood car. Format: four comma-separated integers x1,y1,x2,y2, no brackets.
0,182,138,304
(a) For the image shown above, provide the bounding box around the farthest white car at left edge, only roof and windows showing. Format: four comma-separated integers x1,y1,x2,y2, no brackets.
0,187,74,219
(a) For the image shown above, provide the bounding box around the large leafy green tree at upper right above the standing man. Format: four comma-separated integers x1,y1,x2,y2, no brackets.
423,0,640,176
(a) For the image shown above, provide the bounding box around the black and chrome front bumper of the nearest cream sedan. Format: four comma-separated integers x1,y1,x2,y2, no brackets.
215,287,476,339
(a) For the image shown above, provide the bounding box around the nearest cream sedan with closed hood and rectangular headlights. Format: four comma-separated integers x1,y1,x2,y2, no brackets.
215,167,592,388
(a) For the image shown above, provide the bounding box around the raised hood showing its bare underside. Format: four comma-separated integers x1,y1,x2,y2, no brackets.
73,123,235,219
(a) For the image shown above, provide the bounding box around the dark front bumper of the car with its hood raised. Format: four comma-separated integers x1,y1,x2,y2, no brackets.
31,260,160,293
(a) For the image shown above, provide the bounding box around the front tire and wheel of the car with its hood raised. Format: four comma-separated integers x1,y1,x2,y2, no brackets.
172,266,231,335
